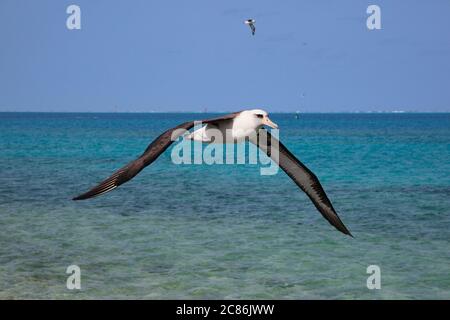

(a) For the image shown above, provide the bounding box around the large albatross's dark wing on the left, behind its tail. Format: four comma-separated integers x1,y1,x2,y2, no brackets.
72,112,239,200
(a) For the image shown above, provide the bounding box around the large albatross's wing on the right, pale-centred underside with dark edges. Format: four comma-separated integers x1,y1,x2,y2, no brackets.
251,129,353,237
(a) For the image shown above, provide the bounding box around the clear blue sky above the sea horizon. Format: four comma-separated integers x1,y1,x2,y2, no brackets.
0,0,450,112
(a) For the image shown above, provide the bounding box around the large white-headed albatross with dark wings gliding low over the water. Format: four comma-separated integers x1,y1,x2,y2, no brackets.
73,109,352,236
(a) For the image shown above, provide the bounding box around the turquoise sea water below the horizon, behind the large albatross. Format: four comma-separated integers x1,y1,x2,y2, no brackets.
0,113,450,299
